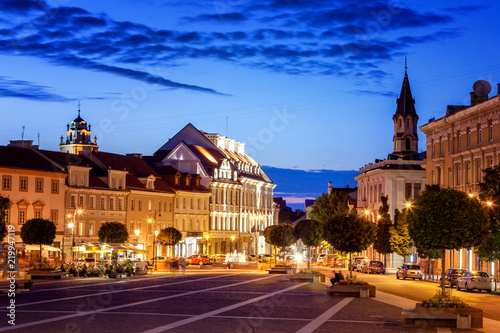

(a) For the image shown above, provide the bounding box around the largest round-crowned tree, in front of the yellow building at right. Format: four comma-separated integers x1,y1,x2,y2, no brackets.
406,187,489,296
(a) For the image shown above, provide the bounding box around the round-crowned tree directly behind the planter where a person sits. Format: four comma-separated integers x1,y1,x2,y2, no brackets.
323,212,375,277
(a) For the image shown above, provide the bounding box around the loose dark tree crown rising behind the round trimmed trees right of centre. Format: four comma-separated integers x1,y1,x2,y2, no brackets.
309,192,349,223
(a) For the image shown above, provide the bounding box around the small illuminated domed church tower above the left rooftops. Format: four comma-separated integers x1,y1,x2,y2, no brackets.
59,104,99,154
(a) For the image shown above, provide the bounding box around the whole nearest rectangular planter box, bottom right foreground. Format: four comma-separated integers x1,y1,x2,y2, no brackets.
403,303,483,328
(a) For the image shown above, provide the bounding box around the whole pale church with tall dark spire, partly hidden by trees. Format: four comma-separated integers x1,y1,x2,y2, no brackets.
354,68,426,267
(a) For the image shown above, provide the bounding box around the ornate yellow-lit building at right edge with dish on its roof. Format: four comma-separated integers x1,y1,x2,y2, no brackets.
420,81,500,278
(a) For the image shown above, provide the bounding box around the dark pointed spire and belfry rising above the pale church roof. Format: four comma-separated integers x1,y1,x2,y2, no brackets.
392,61,418,157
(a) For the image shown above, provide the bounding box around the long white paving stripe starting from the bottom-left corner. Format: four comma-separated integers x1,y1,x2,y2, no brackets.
0,276,276,332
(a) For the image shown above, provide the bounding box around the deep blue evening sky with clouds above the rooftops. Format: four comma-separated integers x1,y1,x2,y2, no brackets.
0,0,500,202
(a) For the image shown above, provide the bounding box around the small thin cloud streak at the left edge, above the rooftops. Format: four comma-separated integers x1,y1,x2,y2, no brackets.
0,76,74,102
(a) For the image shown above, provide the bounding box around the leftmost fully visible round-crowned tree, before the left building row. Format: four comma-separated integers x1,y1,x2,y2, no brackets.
21,219,56,267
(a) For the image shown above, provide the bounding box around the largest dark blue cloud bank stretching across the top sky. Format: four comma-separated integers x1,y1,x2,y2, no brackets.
0,0,467,95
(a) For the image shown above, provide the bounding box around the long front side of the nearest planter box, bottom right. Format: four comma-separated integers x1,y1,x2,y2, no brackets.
401,309,472,329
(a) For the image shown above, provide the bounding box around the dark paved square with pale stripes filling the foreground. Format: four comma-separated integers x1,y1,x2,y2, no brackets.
0,269,496,333
